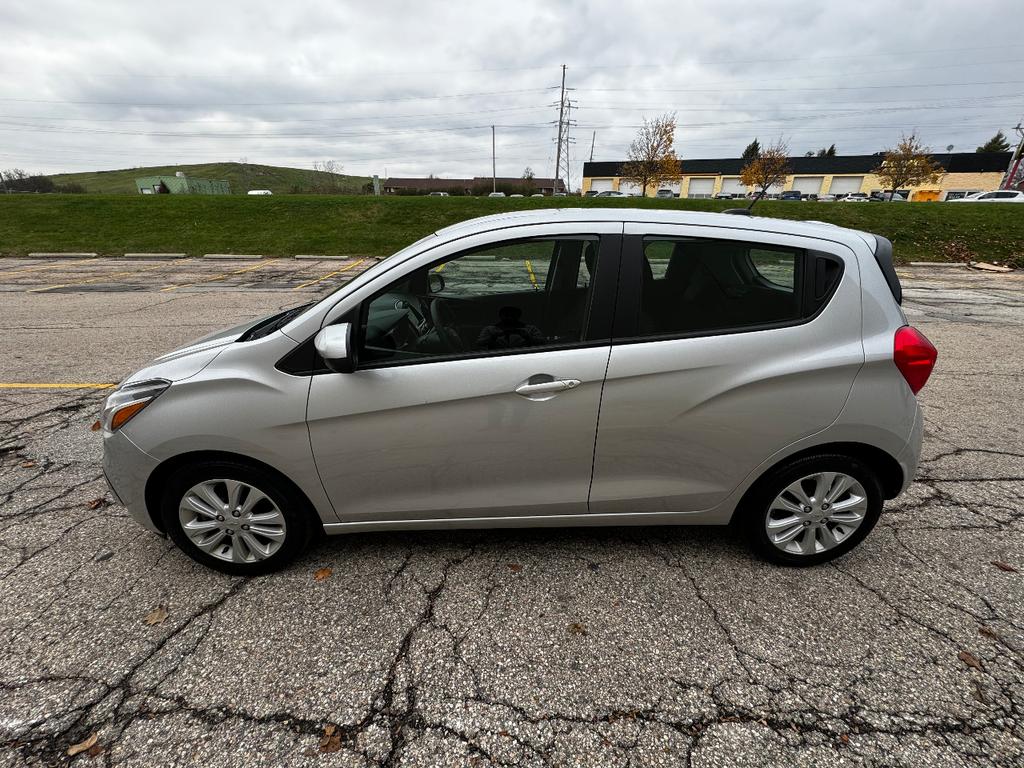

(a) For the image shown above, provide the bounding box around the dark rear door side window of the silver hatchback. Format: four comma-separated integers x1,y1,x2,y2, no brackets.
639,238,805,336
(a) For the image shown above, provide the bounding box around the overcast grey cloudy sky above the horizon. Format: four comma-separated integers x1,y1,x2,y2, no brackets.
0,0,1024,185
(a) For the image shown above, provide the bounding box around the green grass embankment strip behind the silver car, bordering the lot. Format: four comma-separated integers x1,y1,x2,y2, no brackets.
0,195,1024,266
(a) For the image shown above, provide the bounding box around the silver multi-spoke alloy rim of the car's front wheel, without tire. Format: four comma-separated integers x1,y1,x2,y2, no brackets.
178,479,287,563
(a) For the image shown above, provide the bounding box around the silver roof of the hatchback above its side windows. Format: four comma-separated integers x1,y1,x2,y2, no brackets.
435,208,873,250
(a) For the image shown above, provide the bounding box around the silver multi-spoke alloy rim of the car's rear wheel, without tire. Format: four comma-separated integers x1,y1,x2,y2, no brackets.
765,472,867,555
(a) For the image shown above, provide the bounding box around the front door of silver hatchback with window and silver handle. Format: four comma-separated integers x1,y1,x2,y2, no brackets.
307,224,622,524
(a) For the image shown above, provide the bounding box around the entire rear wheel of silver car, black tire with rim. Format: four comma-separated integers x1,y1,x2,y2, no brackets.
738,454,883,567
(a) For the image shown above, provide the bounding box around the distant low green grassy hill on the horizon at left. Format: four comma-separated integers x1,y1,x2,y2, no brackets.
50,163,370,195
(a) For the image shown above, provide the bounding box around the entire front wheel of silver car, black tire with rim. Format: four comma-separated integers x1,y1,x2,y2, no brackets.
160,461,316,575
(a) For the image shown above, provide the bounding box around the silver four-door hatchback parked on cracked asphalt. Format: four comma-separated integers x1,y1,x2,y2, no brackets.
101,209,936,573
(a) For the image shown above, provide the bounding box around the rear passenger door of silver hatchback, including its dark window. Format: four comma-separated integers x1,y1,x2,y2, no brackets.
590,224,863,514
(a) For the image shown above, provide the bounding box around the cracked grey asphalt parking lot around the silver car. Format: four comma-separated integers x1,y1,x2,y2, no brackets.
0,259,1024,768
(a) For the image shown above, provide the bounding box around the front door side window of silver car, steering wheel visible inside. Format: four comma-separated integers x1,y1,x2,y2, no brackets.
358,237,598,368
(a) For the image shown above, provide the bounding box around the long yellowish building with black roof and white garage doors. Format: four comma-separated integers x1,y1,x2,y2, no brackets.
582,152,1011,201
